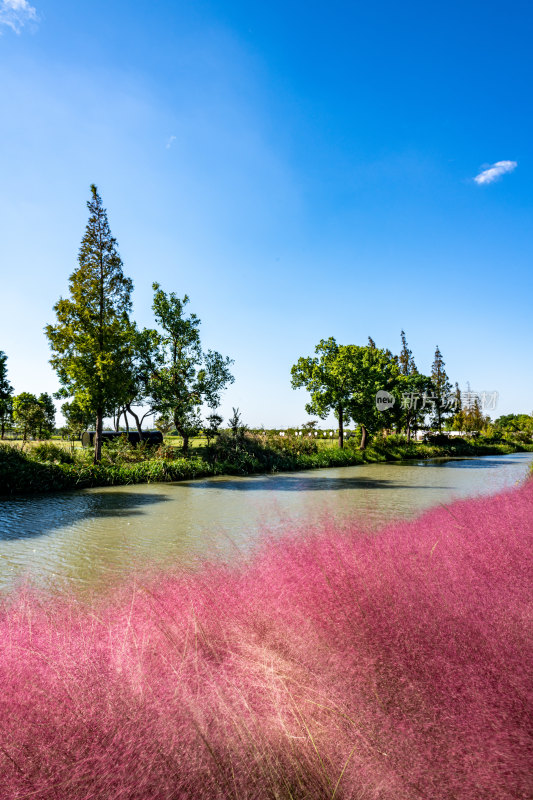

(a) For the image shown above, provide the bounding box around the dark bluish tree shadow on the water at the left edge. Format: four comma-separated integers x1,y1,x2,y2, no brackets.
0,491,169,541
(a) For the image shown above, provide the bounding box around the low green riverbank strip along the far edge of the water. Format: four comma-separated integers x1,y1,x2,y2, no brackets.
0,439,533,497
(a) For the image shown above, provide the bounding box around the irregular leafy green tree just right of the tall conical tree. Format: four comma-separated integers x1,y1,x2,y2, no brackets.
143,283,234,453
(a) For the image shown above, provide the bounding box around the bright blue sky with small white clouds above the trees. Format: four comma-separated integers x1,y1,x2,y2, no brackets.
0,0,533,427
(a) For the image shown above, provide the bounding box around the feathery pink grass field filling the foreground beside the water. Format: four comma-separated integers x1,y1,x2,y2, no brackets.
0,481,533,800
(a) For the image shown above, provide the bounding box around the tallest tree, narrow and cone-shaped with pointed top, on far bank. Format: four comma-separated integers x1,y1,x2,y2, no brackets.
46,184,133,463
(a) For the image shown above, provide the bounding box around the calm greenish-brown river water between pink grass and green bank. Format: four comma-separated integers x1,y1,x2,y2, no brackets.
0,453,533,591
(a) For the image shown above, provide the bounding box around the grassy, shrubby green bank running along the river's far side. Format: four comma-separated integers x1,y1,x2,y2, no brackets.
0,436,533,496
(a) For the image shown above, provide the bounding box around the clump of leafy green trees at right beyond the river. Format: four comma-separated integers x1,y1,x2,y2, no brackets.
291,331,520,450
